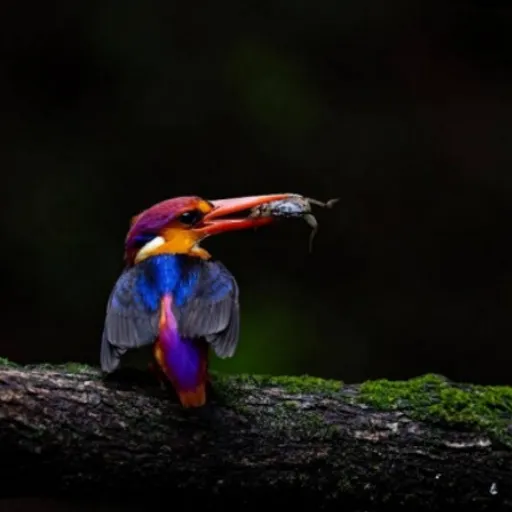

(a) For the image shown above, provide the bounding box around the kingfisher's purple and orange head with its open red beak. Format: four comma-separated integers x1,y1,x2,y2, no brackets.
125,194,290,265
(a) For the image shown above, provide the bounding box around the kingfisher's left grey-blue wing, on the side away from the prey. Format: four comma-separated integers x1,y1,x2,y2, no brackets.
100,267,158,373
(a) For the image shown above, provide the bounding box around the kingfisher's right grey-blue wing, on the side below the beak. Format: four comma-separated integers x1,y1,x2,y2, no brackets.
177,261,240,358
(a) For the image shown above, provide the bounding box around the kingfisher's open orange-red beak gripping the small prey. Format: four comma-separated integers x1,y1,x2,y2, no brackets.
194,194,291,237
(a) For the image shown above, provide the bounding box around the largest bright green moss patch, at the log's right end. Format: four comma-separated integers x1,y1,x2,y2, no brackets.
358,374,512,446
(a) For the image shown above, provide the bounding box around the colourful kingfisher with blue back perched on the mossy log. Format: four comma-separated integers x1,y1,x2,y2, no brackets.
100,194,291,408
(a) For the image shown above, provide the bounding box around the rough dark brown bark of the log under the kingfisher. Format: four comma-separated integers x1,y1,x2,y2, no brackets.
0,367,512,511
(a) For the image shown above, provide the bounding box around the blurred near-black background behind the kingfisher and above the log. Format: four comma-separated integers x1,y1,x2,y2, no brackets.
0,0,512,384
